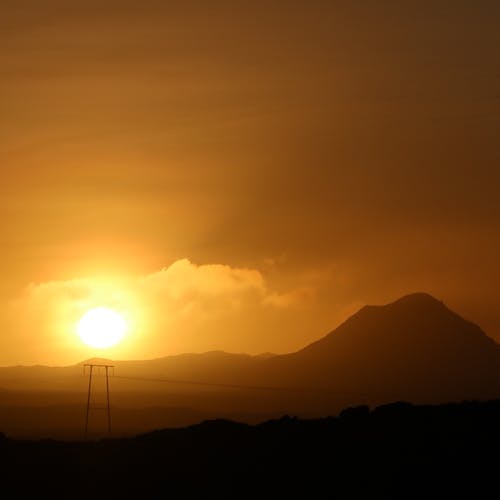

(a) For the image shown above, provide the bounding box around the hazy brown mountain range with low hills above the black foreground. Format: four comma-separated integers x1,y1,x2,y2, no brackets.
0,293,500,433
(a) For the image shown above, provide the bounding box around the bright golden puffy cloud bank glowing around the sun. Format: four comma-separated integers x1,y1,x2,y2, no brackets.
3,259,314,362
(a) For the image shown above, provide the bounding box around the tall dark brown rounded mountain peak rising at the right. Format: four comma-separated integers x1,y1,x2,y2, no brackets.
271,293,500,403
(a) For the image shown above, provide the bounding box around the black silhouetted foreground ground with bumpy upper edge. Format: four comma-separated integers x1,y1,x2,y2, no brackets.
0,401,500,499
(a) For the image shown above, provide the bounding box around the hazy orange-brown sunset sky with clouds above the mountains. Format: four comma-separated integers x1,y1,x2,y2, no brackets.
0,0,500,364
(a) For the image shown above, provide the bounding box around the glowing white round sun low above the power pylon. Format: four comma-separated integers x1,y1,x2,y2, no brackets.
77,307,127,348
